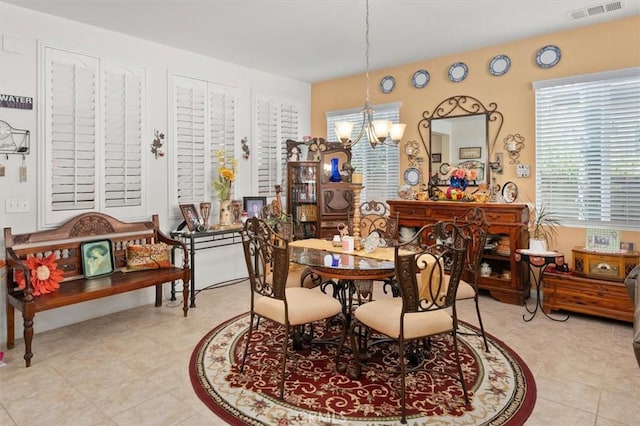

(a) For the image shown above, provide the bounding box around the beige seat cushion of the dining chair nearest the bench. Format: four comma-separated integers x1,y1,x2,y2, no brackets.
254,287,342,325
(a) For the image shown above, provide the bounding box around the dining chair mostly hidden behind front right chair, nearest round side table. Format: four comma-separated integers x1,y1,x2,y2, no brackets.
453,207,489,352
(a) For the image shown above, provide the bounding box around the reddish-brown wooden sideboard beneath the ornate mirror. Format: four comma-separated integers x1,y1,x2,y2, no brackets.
387,200,531,305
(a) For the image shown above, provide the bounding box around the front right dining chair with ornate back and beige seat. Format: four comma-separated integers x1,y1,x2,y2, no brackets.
336,222,469,424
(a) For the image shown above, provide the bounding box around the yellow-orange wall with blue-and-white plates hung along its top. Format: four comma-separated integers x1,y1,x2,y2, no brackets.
311,16,640,261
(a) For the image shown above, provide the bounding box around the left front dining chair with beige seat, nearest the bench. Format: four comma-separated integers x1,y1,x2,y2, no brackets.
240,218,346,399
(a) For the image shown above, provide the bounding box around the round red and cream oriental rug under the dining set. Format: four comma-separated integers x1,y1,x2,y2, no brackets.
189,314,536,426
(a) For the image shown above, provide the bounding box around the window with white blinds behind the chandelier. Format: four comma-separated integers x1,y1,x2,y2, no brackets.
327,102,401,202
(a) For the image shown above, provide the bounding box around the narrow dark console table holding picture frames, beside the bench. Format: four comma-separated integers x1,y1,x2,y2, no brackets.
171,225,247,308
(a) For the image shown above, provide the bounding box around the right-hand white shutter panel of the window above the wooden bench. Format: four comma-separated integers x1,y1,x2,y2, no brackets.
103,64,145,208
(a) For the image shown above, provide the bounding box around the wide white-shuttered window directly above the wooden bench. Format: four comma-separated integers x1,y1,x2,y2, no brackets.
40,44,146,226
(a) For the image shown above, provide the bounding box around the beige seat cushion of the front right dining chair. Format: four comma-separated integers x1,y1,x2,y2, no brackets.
354,297,453,339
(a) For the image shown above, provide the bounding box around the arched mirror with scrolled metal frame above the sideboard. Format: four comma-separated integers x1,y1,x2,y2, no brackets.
418,96,503,186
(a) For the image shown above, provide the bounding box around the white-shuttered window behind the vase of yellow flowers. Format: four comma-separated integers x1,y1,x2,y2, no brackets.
172,76,237,210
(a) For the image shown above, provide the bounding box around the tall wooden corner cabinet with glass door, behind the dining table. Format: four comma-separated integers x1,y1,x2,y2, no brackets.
287,149,354,239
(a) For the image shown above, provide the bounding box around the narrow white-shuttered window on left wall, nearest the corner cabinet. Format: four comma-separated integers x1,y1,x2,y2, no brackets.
255,96,300,197
